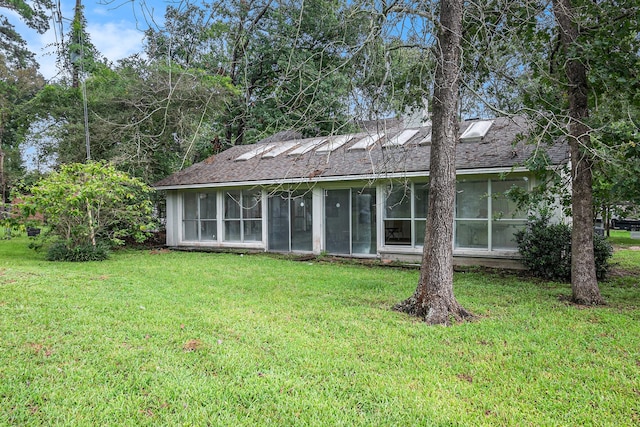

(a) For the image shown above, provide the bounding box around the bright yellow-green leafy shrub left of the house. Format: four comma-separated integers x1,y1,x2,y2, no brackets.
26,162,158,259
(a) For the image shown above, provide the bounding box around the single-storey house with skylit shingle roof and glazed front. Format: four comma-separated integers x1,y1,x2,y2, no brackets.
155,117,569,267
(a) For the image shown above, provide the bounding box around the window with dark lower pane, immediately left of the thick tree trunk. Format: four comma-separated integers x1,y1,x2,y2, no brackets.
384,183,429,246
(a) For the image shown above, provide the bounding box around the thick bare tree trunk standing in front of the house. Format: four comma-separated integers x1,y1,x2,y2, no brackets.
395,0,471,324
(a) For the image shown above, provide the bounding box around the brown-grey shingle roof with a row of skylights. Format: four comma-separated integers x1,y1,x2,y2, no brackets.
154,117,569,189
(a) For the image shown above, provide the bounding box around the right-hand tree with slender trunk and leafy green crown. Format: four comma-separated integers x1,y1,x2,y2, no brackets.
522,0,640,304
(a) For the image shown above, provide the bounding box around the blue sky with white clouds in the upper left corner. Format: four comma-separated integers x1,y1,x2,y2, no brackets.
6,0,175,80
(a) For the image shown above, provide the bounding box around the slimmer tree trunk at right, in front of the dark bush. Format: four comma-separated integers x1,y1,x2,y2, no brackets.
553,0,604,305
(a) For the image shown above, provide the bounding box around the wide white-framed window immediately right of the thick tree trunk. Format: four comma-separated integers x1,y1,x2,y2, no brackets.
454,179,527,250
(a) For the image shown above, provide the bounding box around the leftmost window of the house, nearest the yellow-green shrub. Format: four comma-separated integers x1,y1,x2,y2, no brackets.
182,192,217,242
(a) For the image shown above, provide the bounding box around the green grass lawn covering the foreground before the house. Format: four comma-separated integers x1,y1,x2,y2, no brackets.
0,238,640,426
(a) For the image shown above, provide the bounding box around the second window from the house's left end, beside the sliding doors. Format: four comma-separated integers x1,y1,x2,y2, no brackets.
224,190,262,242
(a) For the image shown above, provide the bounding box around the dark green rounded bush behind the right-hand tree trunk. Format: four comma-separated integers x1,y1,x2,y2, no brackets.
515,217,613,282
